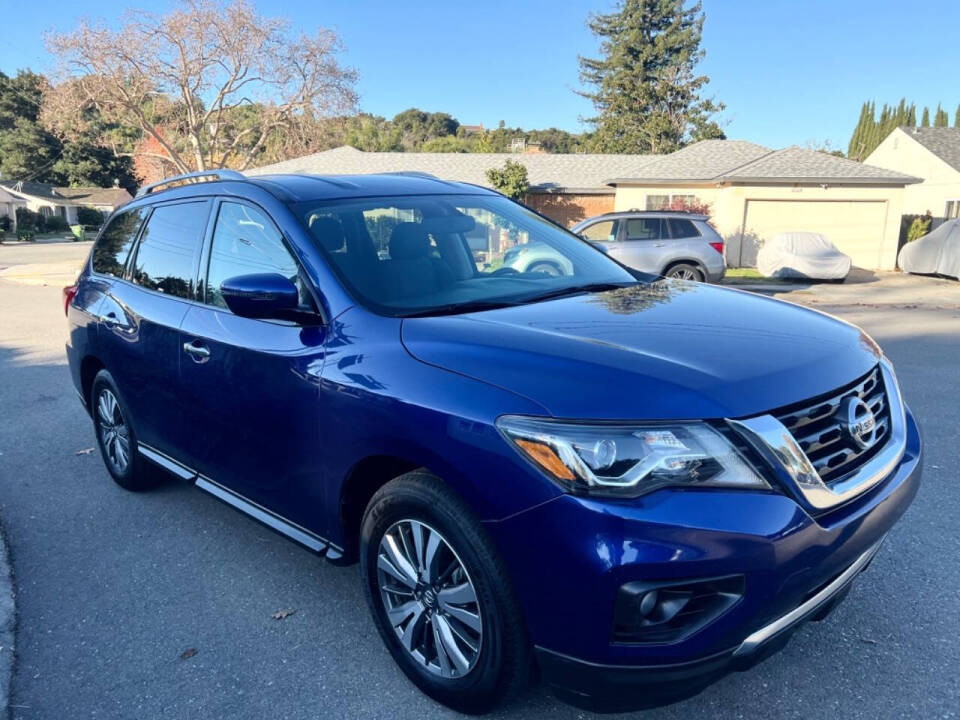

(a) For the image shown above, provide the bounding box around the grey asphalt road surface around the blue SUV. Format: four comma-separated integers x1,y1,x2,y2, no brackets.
0,248,960,720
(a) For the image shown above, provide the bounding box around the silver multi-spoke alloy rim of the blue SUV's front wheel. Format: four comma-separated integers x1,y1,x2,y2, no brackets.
377,520,483,678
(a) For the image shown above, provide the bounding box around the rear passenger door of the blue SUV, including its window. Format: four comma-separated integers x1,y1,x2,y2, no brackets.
94,199,210,455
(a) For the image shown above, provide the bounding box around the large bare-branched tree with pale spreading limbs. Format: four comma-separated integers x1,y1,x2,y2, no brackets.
43,0,357,172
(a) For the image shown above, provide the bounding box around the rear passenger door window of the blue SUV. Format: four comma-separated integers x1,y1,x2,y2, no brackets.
132,202,207,298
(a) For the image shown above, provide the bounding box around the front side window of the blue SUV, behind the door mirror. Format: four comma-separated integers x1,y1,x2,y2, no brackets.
205,202,305,307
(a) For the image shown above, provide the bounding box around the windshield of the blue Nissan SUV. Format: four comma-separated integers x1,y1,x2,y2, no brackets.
294,195,636,316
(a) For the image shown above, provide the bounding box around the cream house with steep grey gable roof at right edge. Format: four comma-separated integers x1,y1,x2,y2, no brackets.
866,127,960,219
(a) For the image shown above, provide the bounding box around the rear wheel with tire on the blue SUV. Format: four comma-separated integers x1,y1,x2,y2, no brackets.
90,370,160,491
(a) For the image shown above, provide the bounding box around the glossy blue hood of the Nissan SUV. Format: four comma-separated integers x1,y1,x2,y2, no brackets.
402,281,880,420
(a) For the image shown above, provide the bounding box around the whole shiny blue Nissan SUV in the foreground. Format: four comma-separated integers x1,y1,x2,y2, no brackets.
65,171,921,712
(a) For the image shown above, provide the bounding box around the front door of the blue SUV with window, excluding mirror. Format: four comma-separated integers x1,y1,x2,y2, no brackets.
180,199,325,532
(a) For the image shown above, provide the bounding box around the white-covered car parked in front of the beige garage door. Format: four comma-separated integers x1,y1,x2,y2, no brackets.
757,232,851,280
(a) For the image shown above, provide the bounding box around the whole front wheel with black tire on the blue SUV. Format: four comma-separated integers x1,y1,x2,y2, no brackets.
360,470,530,713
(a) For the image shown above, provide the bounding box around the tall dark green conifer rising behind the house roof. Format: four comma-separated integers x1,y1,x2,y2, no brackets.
579,0,723,153
